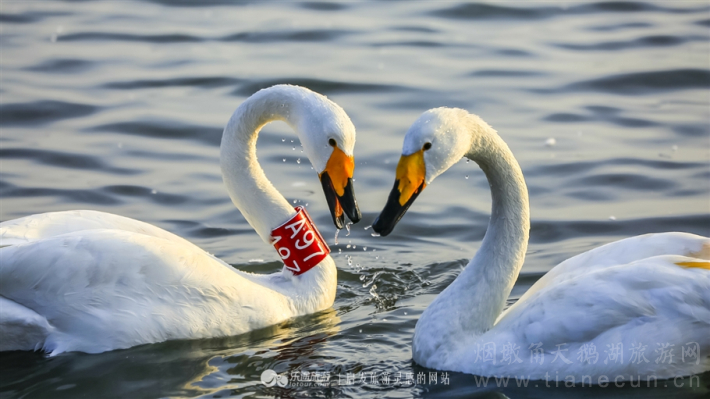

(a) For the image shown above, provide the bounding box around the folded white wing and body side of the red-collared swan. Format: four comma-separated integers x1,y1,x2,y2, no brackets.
0,229,292,354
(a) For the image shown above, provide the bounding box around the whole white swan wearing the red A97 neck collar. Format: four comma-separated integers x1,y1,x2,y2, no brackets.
0,85,360,355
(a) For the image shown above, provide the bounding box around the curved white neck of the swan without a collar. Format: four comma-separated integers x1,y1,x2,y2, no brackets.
414,129,530,359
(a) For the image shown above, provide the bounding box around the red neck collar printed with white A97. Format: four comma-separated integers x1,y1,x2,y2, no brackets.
271,206,330,276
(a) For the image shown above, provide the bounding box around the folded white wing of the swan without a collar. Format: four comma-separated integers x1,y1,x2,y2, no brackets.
468,255,710,378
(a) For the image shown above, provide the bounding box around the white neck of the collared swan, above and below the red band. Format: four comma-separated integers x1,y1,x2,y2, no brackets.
220,86,337,300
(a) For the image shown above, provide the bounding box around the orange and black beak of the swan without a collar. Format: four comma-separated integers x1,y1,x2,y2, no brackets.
372,150,426,236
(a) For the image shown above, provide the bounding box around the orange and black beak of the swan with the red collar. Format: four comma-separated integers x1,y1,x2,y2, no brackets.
319,147,362,229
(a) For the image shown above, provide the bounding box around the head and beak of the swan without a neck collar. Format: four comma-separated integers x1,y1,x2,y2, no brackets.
372,107,482,236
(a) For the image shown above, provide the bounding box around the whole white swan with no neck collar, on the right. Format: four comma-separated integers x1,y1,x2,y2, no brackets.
373,108,710,385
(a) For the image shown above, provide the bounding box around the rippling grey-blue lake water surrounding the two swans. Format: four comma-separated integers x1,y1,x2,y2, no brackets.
0,0,710,398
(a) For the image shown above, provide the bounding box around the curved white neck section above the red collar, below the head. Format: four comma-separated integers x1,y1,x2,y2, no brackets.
220,88,308,243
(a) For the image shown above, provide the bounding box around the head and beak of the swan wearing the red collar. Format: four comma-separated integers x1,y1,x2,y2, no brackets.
295,89,362,229
